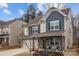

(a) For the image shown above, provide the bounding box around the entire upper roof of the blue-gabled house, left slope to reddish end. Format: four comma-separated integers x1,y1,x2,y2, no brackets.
25,7,70,26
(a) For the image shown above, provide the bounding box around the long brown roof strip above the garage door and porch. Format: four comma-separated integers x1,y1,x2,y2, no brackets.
24,31,64,39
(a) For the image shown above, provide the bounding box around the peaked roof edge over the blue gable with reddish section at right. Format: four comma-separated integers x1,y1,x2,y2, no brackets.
41,7,70,22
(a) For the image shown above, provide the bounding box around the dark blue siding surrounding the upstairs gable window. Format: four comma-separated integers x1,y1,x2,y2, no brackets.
46,11,64,32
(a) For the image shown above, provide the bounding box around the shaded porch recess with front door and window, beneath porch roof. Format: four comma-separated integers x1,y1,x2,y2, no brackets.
39,37,62,50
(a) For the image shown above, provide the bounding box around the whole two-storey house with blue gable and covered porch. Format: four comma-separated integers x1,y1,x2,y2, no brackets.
23,7,73,50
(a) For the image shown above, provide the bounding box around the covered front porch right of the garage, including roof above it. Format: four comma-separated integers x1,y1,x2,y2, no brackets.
38,31,65,50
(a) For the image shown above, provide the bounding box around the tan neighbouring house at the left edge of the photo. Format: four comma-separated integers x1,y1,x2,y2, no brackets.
0,20,26,47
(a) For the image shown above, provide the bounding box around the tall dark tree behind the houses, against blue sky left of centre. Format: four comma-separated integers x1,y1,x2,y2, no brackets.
22,4,36,22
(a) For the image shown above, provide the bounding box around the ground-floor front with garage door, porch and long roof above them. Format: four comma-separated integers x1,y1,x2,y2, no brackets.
23,32,65,50
